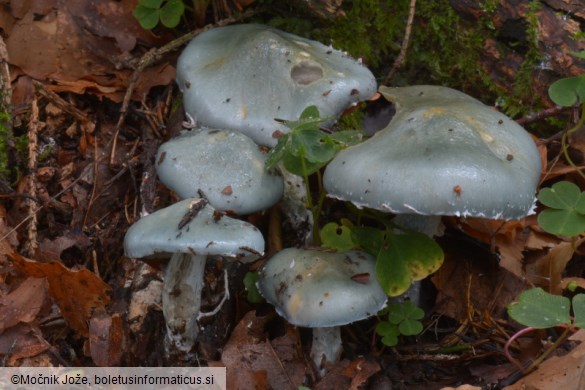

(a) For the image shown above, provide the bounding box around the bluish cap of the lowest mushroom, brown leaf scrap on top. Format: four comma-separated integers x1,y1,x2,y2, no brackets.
258,248,388,328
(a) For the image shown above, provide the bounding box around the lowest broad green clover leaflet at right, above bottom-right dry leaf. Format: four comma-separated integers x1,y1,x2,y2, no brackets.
508,287,571,329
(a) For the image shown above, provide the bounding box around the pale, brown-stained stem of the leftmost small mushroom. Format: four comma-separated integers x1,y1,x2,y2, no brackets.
162,253,206,352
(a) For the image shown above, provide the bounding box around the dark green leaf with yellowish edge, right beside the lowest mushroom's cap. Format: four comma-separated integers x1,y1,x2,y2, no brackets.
376,232,444,296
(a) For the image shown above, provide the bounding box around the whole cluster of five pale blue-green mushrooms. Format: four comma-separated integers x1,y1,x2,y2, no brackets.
124,24,540,372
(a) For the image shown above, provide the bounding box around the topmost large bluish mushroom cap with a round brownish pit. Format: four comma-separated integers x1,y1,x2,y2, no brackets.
177,24,376,146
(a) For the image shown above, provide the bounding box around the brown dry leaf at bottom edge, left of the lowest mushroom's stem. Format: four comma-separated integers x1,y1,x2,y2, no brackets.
214,311,305,390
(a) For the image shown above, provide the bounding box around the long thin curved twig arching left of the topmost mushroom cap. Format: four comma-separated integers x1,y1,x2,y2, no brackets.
110,10,253,165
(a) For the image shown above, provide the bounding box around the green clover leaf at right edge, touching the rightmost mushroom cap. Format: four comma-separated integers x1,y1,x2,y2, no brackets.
537,181,585,236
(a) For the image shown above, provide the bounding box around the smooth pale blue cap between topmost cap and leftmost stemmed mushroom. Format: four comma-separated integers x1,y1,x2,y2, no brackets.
156,128,284,215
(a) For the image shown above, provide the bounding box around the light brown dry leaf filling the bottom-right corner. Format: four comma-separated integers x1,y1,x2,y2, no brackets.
504,329,585,390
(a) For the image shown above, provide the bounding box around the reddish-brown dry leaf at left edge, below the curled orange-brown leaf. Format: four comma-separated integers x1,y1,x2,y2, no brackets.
0,278,48,333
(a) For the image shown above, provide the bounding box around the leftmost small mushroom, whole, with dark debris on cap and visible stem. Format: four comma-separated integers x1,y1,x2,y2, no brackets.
124,198,264,352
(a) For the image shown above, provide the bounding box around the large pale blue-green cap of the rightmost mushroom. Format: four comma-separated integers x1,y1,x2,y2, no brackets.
323,86,541,219
